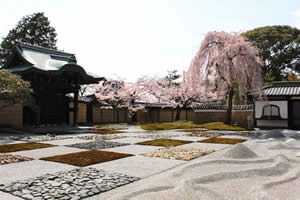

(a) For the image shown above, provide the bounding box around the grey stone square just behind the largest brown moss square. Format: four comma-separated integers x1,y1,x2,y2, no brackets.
67,140,130,149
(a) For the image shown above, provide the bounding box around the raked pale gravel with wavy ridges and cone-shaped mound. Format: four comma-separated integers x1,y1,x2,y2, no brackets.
88,130,300,200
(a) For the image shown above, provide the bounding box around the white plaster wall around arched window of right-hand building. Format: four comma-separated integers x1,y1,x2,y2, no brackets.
255,101,288,119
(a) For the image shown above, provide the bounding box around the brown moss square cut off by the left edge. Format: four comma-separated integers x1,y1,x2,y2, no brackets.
0,143,56,153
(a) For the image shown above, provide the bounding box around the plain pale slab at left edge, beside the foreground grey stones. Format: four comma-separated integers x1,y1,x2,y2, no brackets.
0,160,77,184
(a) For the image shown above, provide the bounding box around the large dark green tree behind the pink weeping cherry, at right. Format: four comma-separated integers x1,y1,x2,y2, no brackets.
242,26,300,81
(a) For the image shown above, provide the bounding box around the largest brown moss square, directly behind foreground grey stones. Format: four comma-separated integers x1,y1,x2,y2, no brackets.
40,150,133,167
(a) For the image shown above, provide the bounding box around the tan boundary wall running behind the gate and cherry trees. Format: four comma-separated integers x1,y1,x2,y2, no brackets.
0,102,253,128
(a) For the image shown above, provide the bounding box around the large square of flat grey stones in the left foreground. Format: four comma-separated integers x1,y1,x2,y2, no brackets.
0,168,139,200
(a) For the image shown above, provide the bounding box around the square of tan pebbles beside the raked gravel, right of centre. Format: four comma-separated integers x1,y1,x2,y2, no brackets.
141,147,215,161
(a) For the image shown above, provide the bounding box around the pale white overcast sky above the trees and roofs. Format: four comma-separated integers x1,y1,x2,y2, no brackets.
0,0,300,81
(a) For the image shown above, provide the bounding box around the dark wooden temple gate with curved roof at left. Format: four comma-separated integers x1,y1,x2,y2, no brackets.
3,43,103,125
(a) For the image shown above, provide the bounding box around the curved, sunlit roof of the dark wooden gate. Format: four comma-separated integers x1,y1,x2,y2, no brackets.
5,43,103,84
